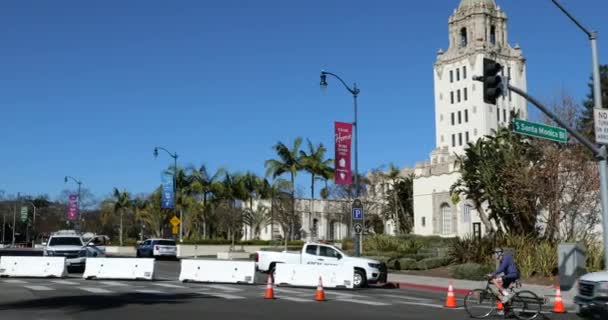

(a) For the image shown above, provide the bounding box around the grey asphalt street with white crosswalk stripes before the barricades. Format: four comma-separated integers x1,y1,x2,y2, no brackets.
0,261,576,320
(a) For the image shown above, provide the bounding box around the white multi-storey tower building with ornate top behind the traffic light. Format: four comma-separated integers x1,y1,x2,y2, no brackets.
414,0,528,236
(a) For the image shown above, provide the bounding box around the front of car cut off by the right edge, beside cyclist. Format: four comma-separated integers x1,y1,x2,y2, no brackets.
574,271,608,319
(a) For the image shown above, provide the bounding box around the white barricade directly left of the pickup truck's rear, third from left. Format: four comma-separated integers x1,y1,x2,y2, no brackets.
179,259,255,283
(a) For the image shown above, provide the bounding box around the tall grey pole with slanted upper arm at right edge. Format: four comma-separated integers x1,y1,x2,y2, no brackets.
551,0,608,270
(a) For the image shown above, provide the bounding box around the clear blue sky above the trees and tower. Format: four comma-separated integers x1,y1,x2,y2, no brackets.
0,0,608,198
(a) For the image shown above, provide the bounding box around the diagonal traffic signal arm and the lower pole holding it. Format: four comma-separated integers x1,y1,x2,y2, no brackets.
484,77,608,270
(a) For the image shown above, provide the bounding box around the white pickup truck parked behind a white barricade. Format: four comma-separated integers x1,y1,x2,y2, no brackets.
256,243,387,288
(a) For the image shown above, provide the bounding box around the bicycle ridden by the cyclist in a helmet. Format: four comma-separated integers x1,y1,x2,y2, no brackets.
464,279,544,320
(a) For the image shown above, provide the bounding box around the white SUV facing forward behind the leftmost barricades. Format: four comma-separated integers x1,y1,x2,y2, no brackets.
43,230,84,268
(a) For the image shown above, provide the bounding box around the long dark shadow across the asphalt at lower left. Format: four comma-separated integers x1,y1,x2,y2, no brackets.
0,292,220,313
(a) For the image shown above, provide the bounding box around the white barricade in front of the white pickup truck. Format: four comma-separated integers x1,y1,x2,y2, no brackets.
274,263,355,289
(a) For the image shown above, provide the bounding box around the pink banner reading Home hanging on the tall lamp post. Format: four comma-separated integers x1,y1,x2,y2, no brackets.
334,122,353,184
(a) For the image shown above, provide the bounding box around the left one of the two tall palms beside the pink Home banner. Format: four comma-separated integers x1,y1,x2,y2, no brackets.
264,137,302,240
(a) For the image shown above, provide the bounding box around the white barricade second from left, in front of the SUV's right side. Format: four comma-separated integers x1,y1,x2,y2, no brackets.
82,258,154,280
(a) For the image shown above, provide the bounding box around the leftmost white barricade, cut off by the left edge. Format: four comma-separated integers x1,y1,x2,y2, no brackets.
0,256,68,278
